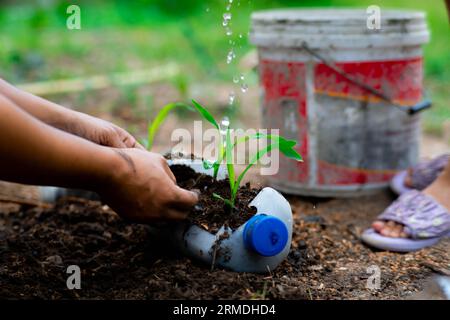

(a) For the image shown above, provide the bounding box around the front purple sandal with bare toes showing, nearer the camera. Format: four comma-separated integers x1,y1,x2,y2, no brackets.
361,190,450,252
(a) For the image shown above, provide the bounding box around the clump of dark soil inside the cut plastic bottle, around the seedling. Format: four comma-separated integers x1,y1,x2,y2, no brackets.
170,165,261,233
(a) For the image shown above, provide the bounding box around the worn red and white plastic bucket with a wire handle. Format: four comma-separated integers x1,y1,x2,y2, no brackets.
250,9,431,197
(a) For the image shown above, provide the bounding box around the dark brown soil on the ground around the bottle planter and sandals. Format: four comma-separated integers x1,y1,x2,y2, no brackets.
0,188,450,299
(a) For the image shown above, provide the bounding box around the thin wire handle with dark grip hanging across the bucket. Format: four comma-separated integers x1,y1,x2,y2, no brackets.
302,42,432,115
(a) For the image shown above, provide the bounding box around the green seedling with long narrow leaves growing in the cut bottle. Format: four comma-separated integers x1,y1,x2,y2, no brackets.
147,100,303,209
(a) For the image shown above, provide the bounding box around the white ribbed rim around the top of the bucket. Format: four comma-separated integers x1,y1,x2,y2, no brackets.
250,9,429,48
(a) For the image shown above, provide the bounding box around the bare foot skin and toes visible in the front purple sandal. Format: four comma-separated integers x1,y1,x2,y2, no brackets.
372,172,450,238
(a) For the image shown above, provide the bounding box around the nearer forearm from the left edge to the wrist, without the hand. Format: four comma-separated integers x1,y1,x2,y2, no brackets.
0,96,120,189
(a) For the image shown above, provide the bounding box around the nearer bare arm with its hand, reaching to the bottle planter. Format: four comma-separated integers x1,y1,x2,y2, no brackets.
0,95,197,222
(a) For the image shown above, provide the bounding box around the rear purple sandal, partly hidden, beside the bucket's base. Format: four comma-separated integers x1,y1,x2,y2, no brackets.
391,154,450,195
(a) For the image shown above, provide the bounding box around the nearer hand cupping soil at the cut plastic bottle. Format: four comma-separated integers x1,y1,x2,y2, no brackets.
99,149,198,223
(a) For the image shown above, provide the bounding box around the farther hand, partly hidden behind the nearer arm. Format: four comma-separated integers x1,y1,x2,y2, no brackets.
61,112,144,150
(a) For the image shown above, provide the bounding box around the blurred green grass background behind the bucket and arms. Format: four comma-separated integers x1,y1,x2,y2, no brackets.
0,0,450,134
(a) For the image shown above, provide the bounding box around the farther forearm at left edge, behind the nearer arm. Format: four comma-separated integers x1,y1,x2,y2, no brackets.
0,79,77,132
